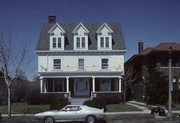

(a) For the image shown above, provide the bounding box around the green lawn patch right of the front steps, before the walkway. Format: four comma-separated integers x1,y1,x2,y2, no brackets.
106,104,142,112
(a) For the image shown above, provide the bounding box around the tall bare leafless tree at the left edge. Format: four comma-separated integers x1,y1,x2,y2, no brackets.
0,33,31,118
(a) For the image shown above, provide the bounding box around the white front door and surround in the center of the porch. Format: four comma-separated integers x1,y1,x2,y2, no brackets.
74,79,89,96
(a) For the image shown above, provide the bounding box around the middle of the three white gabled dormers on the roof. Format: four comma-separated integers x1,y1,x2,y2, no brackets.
72,23,89,50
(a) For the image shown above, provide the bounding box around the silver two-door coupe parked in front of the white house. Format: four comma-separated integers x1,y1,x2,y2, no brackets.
35,105,105,123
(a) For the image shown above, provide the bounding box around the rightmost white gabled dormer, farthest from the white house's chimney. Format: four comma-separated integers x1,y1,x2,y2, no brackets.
96,23,113,50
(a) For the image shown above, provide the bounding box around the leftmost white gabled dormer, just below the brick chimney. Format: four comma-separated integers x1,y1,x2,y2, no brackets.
48,23,65,50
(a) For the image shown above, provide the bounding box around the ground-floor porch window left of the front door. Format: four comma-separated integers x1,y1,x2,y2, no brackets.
54,79,64,92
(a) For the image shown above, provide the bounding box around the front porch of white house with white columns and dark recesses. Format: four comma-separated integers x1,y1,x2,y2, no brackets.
40,77,121,101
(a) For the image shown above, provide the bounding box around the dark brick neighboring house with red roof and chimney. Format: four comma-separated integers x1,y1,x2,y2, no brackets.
125,41,180,101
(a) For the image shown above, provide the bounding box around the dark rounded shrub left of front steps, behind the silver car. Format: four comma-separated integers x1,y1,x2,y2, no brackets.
50,98,70,110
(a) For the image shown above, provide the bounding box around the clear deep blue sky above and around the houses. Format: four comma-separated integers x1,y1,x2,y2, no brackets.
0,0,180,79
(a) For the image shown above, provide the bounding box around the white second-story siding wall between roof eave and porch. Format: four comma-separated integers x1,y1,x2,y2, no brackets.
38,55,124,72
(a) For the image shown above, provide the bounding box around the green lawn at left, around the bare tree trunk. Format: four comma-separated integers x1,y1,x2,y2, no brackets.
0,103,49,114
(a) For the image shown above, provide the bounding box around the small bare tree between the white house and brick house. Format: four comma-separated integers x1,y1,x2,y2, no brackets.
122,66,138,103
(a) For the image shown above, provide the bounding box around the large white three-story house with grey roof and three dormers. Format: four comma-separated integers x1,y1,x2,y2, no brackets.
36,16,126,101
